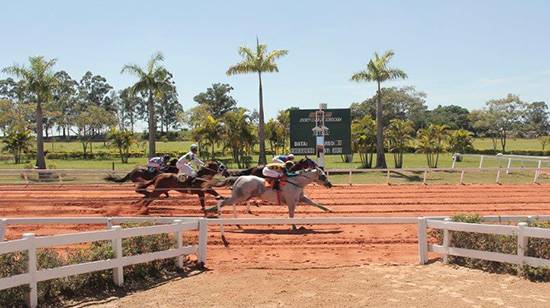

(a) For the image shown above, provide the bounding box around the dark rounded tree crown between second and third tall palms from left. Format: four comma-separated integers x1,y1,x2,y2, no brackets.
193,83,237,119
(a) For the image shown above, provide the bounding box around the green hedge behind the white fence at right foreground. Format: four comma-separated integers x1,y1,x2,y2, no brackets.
430,214,550,281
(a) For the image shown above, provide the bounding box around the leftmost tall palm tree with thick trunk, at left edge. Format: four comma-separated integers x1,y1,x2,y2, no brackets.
2,56,57,169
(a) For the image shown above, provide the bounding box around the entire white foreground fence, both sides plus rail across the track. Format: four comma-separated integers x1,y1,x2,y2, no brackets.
0,215,550,307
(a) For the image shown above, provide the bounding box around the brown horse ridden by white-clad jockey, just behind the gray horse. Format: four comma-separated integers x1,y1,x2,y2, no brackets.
136,161,229,210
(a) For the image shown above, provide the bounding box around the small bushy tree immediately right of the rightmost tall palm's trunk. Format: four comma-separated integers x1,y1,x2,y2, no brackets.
386,119,414,168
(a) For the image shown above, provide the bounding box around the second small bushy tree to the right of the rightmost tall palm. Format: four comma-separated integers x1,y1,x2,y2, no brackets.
417,124,448,168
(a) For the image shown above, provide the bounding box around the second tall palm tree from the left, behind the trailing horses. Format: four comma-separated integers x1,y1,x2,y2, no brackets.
121,52,172,157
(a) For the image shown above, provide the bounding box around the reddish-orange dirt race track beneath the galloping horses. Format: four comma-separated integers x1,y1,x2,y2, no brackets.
0,185,550,268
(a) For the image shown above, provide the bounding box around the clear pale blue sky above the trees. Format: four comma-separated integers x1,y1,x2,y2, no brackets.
0,0,550,117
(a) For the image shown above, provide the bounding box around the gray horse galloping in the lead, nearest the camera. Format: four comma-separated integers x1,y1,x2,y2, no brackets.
207,168,332,224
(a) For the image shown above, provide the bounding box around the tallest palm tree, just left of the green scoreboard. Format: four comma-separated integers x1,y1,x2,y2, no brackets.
227,38,288,164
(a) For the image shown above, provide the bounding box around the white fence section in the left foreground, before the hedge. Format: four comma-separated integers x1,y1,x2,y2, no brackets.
0,219,207,307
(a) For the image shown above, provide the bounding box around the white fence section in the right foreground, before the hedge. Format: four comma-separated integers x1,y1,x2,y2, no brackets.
418,218,550,267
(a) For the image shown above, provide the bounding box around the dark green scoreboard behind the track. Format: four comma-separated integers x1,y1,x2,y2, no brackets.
290,109,352,155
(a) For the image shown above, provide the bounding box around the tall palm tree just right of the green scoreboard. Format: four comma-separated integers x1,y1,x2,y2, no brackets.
351,50,407,168
